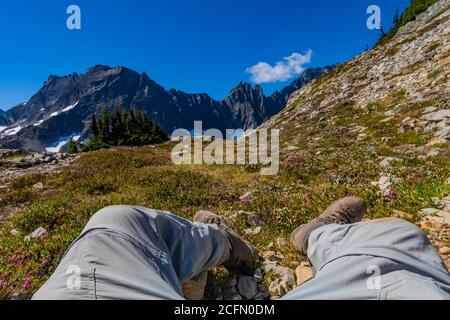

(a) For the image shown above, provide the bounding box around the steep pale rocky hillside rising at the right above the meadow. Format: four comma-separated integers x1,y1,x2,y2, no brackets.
263,0,450,143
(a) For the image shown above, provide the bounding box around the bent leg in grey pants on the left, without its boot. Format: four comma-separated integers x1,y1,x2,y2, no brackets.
34,206,230,299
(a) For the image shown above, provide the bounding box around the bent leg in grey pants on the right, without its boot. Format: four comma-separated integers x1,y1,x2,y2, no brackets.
283,219,450,300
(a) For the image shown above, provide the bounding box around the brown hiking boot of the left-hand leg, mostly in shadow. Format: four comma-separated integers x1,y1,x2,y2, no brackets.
193,211,260,275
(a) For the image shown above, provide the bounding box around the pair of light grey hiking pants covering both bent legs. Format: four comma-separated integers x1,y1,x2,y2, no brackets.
33,206,450,299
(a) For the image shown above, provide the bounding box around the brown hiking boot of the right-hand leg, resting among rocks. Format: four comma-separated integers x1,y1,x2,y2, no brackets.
291,197,367,256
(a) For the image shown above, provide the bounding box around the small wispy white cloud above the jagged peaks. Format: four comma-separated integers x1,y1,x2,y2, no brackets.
245,50,312,83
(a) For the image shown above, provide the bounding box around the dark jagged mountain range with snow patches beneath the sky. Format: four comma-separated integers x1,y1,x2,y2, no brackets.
0,65,331,151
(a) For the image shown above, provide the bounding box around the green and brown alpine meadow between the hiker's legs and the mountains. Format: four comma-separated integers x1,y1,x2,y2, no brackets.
0,112,450,298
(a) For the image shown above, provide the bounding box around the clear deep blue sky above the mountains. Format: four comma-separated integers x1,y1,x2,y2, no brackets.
0,0,409,110
